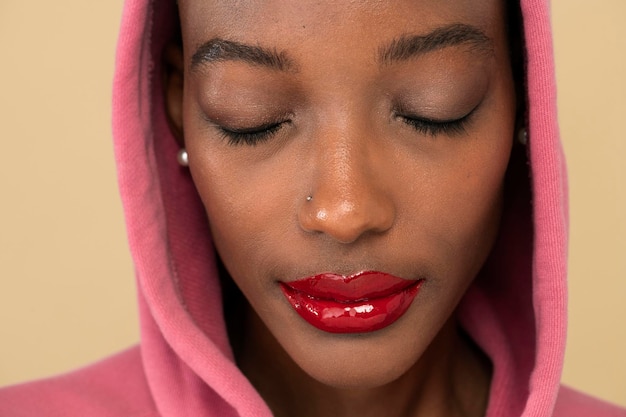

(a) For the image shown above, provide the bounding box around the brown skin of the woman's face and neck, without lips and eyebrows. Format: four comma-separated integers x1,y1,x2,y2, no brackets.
165,0,516,416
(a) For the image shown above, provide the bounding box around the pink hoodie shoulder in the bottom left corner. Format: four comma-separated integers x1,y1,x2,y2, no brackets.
0,347,158,417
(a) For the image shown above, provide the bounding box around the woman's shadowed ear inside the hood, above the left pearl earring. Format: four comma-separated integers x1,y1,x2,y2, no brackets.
162,42,185,147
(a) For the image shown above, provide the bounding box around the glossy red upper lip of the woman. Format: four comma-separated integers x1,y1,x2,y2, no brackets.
281,271,420,302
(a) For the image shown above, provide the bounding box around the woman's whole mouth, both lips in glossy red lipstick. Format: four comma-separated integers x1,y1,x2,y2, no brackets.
280,271,423,333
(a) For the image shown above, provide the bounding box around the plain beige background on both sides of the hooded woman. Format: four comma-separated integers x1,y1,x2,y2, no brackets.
0,0,626,406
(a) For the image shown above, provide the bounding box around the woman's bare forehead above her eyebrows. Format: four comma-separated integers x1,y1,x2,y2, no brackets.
179,0,506,51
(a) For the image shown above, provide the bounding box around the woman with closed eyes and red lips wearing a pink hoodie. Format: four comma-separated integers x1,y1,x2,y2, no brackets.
0,0,623,416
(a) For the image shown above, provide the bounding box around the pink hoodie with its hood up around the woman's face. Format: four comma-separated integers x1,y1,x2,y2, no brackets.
0,0,626,417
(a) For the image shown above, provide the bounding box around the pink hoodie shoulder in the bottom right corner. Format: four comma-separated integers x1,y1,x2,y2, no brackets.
554,386,626,417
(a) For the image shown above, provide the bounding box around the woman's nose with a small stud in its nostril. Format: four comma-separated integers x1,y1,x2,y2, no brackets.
298,135,396,243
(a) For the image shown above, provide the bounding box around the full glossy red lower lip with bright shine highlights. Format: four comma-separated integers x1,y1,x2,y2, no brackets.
280,272,423,333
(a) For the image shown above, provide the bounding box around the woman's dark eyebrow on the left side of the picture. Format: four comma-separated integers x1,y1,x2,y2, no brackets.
191,38,295,71
